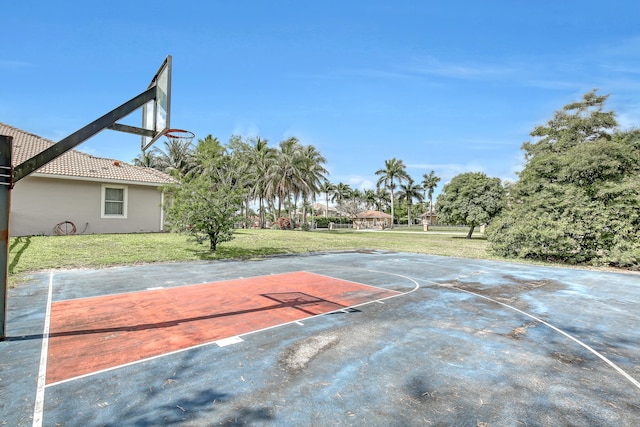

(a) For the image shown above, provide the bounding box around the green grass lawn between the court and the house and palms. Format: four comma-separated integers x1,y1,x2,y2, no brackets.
9,230,490,281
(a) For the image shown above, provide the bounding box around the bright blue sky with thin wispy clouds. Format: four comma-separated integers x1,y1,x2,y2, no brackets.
0,0,640,199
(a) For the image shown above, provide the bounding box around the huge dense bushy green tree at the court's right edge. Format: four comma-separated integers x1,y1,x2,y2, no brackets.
487,91,640,269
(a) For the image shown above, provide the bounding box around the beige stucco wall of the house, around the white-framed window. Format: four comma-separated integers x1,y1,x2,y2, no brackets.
9,176,162,236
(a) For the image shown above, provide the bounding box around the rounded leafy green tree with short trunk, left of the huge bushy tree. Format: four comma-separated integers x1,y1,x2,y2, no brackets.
436,172,504,239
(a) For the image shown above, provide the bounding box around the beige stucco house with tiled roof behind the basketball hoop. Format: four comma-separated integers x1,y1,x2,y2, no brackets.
0,123,175,236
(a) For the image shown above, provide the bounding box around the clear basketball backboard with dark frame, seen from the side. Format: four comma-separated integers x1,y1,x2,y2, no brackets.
141,55,171,151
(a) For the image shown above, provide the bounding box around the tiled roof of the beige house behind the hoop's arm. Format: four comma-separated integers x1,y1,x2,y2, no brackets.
0,122,175,184
